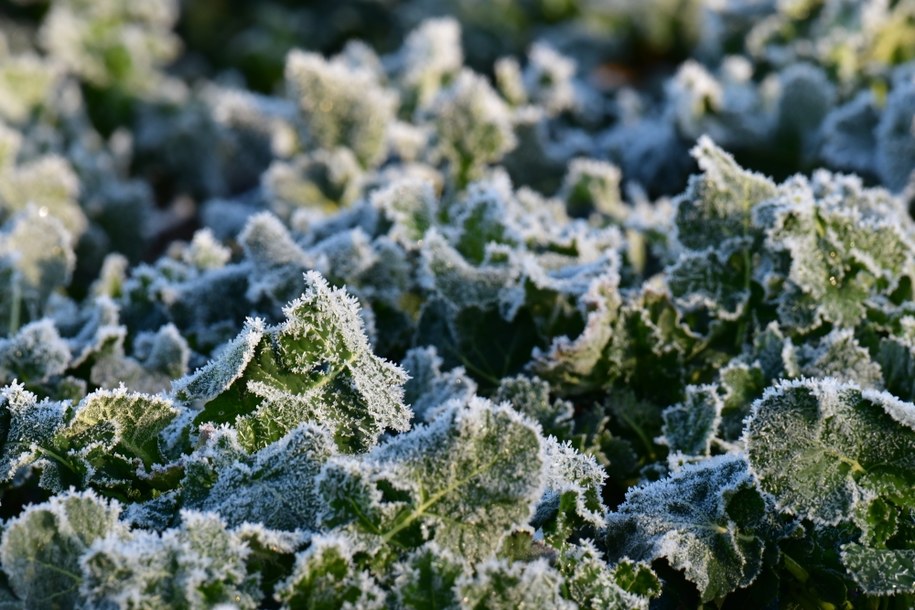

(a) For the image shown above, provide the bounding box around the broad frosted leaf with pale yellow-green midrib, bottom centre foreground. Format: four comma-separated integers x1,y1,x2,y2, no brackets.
320,398,545,560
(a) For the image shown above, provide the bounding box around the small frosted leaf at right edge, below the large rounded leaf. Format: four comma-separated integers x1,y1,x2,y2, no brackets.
842,544,915,595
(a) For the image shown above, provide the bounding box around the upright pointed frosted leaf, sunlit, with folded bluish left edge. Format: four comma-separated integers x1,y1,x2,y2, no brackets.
175,272,410,450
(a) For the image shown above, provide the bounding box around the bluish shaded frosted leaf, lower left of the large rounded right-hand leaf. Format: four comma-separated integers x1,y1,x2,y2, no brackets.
606,455,766,601
